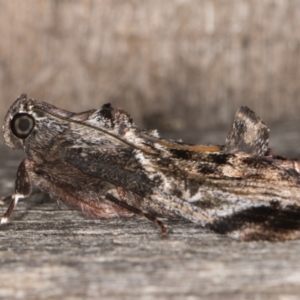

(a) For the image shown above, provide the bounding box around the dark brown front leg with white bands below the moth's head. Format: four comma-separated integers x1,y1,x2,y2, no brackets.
0,159,31,224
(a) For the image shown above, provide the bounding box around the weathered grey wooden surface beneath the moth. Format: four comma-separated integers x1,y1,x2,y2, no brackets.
0,144,300,300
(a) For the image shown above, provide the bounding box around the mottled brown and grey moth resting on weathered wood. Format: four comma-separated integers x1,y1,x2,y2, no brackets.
1,95,300,240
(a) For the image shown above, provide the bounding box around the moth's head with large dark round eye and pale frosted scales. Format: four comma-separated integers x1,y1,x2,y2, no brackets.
3,95,35,149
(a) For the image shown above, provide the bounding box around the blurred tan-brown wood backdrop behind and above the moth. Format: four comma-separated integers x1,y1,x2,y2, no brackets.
0,0,300,148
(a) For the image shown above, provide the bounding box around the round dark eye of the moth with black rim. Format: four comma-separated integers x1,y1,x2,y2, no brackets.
10,114,34,139
